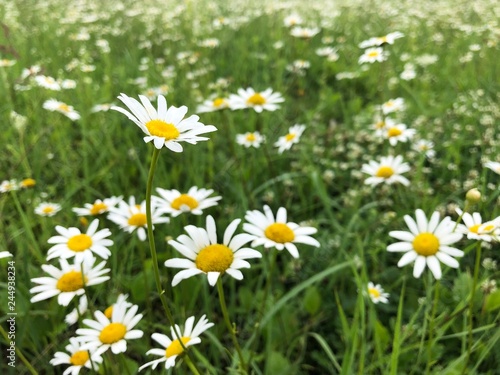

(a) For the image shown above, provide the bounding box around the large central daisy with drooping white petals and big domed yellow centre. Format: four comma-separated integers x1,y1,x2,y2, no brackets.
165,216,262,286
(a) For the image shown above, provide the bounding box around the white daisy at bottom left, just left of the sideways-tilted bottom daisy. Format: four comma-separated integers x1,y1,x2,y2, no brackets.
76,303,144,355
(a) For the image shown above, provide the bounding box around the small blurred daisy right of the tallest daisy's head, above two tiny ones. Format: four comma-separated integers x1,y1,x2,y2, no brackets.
228,87,285,113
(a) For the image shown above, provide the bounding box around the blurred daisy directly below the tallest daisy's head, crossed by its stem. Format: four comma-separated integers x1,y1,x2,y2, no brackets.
108,197,170,241
